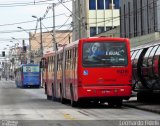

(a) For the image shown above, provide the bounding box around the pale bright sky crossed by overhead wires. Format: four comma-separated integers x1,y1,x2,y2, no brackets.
0,0,72,53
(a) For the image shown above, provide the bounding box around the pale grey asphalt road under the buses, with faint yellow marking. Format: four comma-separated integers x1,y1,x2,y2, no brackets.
0,80,160,126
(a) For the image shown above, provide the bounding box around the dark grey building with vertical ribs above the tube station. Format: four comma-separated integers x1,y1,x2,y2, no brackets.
120,0,160,38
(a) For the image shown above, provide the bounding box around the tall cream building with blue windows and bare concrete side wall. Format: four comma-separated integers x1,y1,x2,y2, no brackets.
72,0,120,41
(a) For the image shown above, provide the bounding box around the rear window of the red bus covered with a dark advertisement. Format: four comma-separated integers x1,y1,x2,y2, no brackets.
83,42,128,67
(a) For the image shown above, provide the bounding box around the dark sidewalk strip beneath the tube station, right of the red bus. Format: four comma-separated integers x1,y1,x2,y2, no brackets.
123,97,160,114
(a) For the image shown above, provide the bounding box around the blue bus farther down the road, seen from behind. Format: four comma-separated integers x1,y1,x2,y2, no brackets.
15,64,41,88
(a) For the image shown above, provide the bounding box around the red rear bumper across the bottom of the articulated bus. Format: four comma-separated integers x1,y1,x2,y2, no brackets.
78,86,132,99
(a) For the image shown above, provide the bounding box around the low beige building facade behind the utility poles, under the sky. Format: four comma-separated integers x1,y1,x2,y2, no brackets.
28,30,72,63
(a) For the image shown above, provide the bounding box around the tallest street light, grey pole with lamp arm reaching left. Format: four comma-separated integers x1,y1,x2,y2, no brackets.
32,15,43,57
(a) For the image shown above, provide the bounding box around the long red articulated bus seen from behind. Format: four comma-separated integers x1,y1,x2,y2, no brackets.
43,37,132,107
